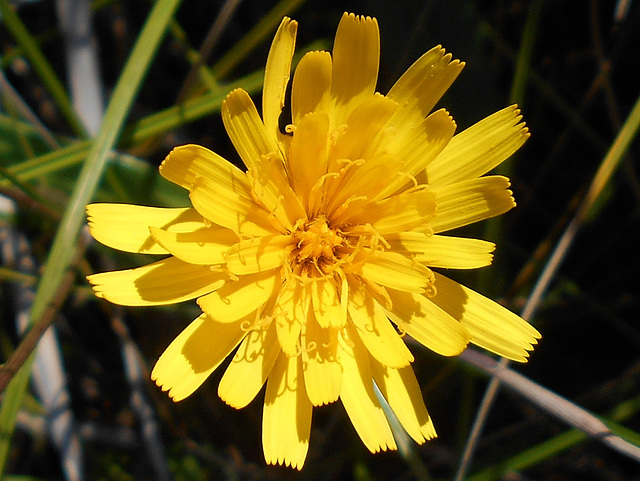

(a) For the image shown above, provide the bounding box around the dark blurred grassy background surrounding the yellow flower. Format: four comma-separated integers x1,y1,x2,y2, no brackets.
0,0,640,481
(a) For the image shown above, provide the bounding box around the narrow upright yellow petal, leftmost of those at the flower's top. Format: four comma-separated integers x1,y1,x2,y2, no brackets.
262,17,298,144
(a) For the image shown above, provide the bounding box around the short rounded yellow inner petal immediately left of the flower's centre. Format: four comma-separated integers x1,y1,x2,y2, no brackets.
227,235,295,275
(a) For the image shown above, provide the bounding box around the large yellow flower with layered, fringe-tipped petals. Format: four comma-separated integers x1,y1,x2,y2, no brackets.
87,14,540,469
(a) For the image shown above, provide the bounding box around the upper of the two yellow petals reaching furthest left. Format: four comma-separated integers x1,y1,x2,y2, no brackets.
87,204,204,254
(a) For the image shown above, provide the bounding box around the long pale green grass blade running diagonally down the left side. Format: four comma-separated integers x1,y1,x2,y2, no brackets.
0,0,180,473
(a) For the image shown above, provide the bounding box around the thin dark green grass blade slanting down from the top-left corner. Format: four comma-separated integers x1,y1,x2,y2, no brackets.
0,0,87,137
